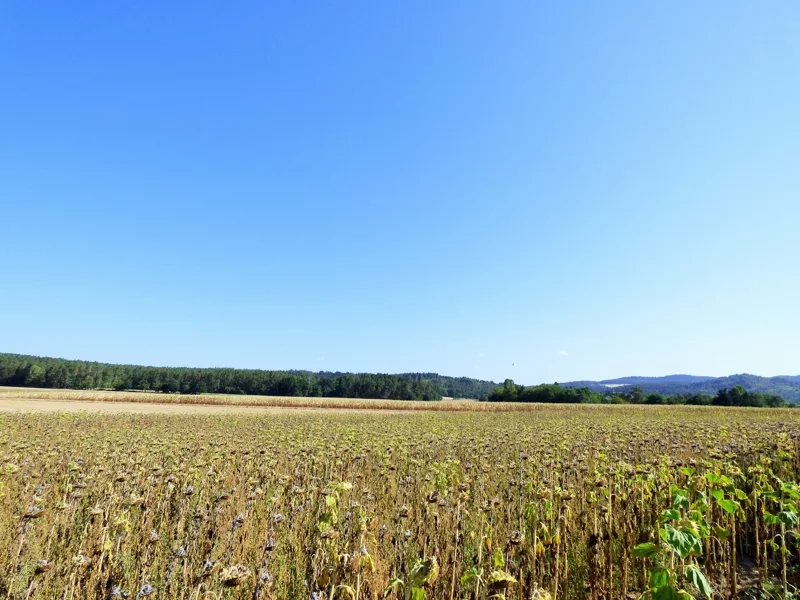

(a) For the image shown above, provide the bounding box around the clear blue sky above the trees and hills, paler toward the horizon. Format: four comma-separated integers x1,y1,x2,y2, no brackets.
0,0,800,384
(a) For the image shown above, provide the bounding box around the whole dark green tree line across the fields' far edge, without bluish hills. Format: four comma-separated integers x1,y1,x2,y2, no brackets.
10,353,794,407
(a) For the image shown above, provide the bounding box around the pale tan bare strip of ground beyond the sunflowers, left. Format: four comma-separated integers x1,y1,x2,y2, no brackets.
0,396,408,415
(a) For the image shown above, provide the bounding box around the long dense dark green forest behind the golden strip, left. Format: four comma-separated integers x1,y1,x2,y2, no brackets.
0,354,497,400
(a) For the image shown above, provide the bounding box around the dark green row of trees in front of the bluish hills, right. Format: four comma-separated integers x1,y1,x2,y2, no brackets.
488,379,794,408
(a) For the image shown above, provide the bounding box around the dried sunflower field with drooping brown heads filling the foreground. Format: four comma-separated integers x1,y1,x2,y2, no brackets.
0,405,800,600
